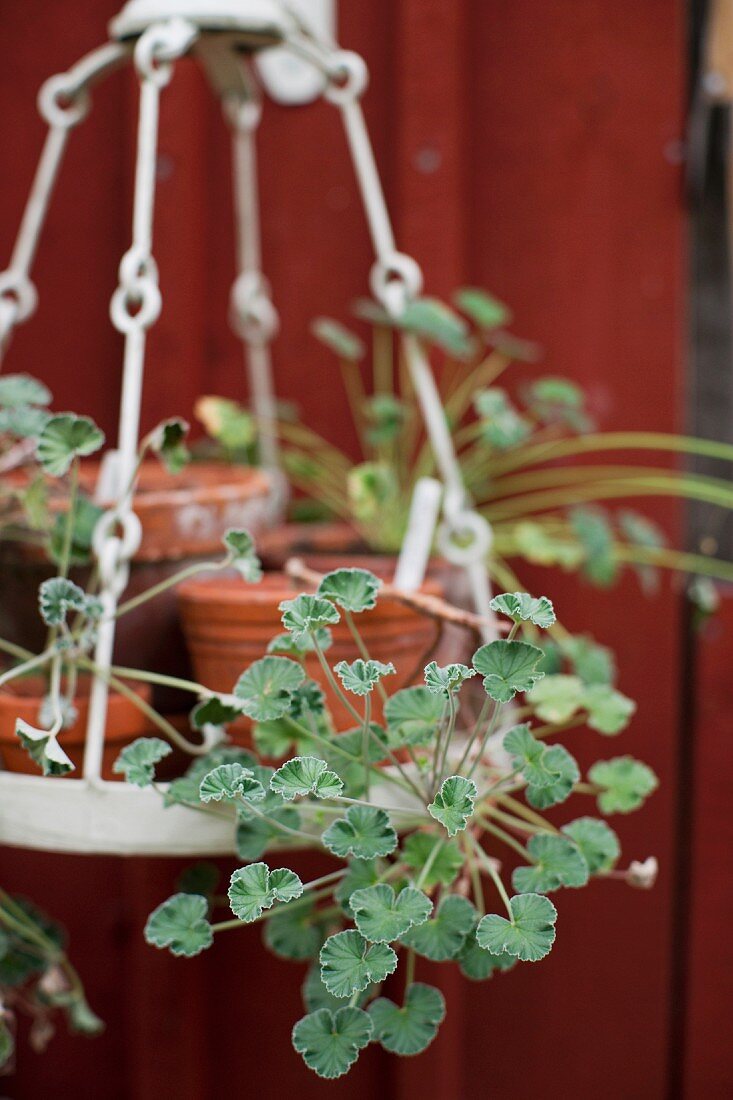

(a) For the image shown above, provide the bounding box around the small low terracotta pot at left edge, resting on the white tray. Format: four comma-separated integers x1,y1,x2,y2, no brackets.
0,677,153,780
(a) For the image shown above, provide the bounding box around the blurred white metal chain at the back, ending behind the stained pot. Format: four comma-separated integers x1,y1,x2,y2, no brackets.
225,67,287,519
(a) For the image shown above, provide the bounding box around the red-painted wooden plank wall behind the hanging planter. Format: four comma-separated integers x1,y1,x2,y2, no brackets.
0,0,721,1100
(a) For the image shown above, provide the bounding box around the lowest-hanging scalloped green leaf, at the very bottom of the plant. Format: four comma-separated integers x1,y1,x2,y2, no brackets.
293,1008,373,1080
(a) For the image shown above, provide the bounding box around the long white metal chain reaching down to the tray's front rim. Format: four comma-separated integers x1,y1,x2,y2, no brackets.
84,19,198,782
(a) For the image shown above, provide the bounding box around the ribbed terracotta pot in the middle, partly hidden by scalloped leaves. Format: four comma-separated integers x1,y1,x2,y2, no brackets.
178,557,442,729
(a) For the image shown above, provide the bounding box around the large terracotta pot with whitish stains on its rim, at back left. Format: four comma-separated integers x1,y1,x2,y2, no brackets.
0,459,270,712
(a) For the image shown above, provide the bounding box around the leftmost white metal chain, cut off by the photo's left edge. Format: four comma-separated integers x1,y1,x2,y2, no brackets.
0,43,129,364
